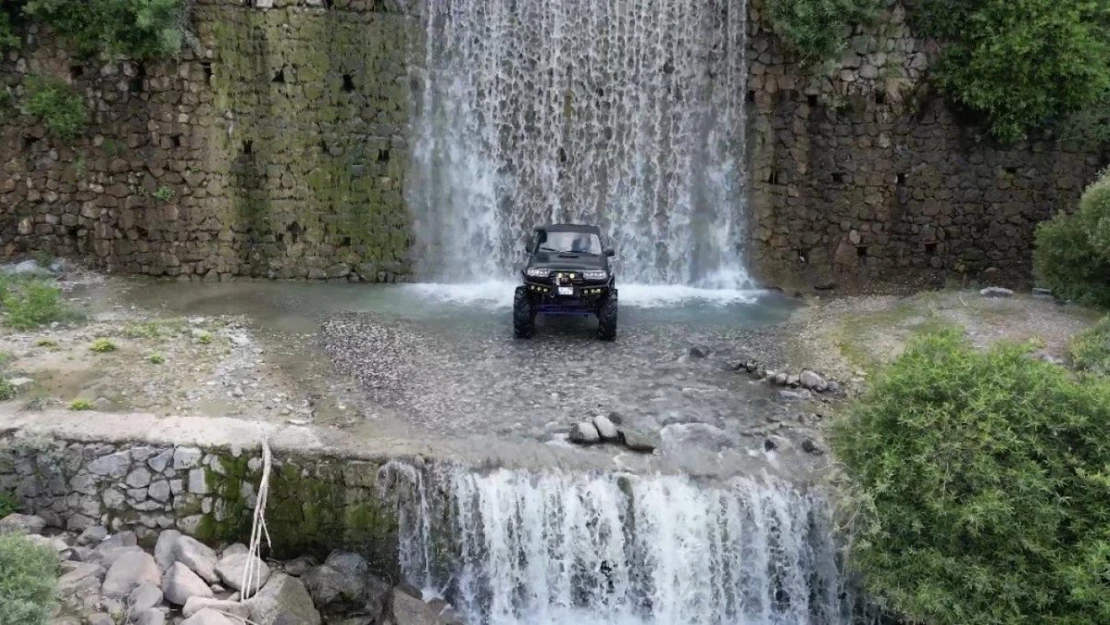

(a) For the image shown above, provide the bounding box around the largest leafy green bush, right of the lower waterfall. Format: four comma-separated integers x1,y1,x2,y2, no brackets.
833,331,1110,625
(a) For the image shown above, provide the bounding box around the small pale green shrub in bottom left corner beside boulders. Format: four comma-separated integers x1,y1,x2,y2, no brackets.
0,533,58,625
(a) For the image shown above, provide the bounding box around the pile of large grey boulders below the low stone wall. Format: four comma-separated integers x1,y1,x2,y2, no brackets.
0,514,461,625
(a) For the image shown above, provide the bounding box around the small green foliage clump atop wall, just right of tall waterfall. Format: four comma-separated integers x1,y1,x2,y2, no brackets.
767,0,882,61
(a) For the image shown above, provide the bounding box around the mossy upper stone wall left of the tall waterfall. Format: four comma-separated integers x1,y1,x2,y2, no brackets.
0,0,421,281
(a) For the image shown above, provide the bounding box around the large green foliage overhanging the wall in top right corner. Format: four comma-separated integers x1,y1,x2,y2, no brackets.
915,0,1110,141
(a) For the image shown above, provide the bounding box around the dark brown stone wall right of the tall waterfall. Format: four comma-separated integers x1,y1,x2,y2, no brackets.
748,0,1110,286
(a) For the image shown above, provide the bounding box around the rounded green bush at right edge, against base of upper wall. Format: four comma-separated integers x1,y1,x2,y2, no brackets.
1033,171,1110,308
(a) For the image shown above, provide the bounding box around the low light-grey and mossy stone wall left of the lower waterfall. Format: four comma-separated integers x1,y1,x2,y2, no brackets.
0,435,397,578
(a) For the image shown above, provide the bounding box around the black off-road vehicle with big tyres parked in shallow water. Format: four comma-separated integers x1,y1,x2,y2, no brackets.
513,224,617,341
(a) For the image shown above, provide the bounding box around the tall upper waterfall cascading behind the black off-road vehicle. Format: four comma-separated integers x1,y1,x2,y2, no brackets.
407,0,750,288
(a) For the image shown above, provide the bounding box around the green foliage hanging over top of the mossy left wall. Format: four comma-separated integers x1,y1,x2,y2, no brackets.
23,0,189,59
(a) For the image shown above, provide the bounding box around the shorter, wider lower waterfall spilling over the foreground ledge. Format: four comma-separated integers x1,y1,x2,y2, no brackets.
380,463,854,625
